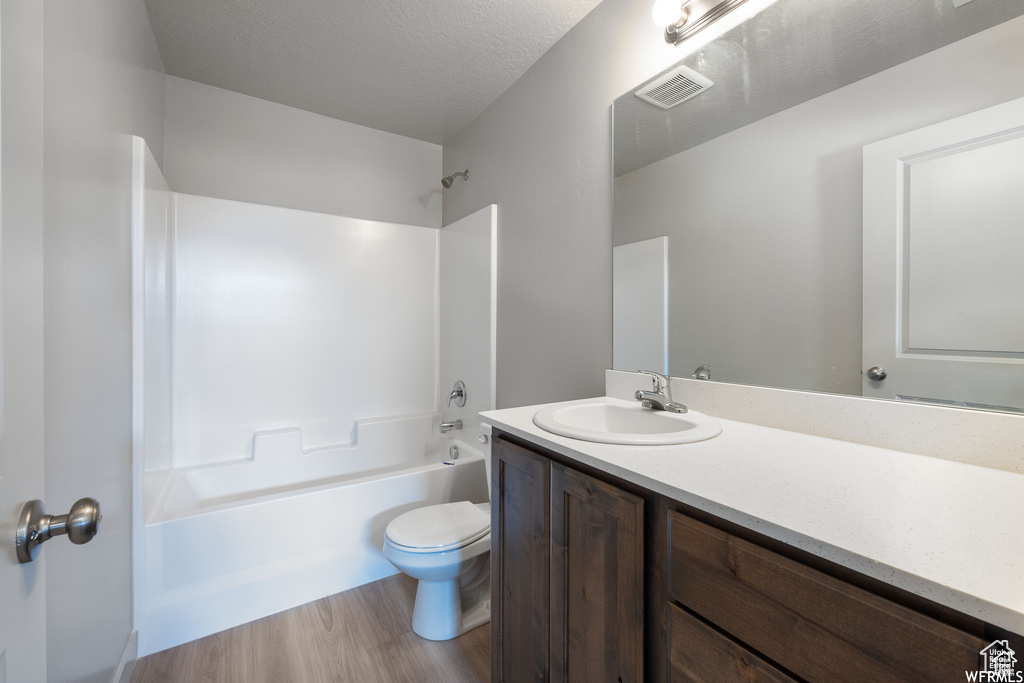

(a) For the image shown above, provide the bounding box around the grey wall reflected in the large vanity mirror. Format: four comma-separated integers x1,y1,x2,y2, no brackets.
614,17,1024,394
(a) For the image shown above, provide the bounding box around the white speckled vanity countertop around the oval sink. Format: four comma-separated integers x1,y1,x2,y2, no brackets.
481,405,1024,634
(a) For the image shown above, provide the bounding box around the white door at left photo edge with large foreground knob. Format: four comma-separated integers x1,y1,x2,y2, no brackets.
0,0,46,683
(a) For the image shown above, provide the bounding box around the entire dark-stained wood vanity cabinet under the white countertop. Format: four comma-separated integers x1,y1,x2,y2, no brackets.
492,431,1024,683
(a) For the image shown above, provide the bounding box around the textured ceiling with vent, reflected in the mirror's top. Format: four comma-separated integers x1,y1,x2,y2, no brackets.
614,0,1024,177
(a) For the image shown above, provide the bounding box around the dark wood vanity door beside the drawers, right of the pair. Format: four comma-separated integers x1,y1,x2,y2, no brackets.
551,463,643,683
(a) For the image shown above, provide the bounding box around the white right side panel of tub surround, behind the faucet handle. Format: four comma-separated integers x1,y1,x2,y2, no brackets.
438,205,498,442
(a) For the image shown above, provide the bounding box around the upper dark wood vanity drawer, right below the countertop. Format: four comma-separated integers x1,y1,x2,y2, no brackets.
669,511,986,683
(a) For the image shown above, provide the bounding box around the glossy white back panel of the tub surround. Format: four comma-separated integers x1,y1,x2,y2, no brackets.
171,194,438,467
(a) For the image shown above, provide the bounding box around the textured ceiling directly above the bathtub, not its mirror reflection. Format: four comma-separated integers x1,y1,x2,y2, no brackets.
145,0,599,143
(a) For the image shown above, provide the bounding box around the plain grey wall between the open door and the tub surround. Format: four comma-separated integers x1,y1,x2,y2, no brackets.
40,0,164,683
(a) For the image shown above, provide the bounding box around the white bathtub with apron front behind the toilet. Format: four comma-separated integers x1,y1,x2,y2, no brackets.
136,413,487,656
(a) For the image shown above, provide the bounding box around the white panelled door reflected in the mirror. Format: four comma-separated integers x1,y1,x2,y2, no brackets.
863,93,1024,411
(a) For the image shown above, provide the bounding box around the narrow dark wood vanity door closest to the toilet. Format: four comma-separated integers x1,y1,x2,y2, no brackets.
490,438,551,683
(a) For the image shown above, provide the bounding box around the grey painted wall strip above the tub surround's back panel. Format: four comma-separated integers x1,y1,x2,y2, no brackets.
164,77,441,227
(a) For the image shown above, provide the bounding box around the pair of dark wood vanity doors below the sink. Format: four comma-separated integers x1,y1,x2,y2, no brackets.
492,438,644,683
